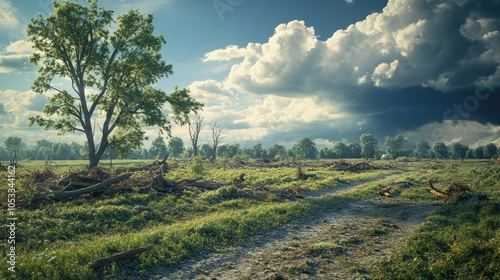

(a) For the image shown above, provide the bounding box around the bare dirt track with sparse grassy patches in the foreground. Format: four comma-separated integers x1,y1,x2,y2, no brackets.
144,177,438,280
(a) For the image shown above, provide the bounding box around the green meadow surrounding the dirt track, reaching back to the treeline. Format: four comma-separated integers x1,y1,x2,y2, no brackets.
0,159,500,279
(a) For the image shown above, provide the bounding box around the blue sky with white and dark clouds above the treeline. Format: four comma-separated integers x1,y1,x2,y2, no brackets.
0,0,500,151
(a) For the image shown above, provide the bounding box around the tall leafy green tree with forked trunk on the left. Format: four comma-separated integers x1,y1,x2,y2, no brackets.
27,0,202,168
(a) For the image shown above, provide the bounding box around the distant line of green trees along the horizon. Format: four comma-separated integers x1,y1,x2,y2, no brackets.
0,136,500,161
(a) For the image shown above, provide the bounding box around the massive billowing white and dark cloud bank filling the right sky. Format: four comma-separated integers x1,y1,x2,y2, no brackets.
188,0,500,148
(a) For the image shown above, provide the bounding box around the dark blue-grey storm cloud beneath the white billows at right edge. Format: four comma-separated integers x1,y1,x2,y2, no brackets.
344,87,500,136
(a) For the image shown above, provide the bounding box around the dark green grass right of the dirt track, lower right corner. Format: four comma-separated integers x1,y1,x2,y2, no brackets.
374,162,500,279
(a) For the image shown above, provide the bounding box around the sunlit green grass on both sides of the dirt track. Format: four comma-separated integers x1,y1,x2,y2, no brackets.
0,161,500,279
